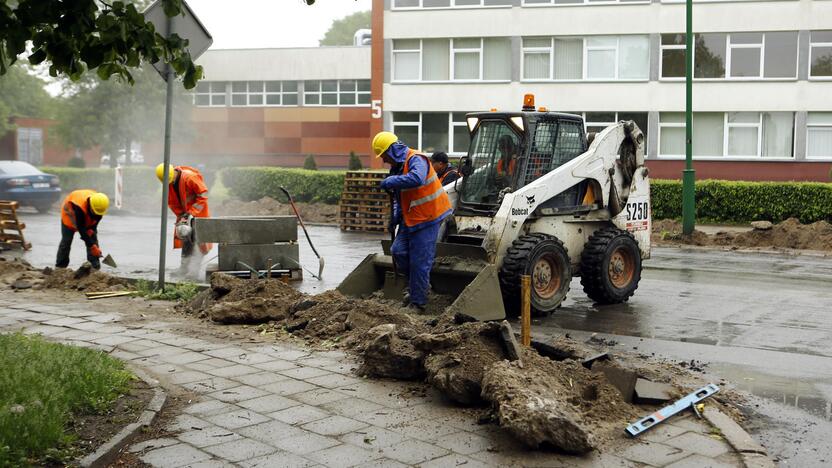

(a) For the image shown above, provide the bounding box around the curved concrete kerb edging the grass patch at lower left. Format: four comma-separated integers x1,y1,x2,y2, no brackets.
78,366,167,468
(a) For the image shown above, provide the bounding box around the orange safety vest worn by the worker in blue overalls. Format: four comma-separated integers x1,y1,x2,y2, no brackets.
401,149,451,227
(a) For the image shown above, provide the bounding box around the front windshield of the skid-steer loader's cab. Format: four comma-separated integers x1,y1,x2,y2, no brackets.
462,120,520,205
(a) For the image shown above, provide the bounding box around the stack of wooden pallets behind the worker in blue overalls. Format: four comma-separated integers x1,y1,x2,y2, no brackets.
338,171,390,232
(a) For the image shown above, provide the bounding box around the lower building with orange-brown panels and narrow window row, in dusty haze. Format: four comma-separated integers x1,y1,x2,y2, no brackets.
184,46,373,168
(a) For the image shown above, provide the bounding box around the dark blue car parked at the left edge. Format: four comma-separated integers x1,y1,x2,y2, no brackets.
0,161,61,213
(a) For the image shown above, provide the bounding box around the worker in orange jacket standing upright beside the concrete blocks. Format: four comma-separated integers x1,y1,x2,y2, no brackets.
156,164,213,268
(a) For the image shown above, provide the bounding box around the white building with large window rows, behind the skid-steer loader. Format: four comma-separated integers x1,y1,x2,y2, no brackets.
373,0,832,181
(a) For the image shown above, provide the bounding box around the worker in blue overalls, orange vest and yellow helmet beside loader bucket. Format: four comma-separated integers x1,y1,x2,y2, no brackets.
373,132,453,311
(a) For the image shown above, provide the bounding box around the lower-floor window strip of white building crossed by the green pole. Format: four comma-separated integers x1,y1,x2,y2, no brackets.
659,112,794,158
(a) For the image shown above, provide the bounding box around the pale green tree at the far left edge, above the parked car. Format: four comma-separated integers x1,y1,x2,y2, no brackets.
0,64,56,136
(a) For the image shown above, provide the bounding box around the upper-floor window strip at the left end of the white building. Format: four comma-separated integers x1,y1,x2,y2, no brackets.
393,37,511,81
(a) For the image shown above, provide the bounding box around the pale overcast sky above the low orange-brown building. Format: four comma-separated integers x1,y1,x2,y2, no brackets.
187,0,372,49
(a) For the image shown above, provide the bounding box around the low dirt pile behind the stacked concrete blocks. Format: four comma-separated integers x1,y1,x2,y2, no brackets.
211,197,338,224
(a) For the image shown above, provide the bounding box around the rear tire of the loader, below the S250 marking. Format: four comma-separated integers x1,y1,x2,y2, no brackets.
581,226,641,304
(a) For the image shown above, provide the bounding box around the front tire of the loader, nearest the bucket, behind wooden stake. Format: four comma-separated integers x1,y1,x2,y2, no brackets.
500,233,572,317
